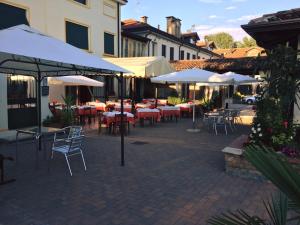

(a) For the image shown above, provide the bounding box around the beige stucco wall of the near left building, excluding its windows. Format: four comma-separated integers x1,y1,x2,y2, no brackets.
0,0,121,128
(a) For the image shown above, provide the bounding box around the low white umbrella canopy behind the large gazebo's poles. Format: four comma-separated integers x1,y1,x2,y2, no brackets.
49,76,104,87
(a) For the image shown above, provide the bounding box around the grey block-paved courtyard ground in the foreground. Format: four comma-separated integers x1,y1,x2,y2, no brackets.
0,119,273,225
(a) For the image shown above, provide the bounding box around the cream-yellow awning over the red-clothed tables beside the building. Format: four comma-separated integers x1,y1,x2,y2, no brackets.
105,56,175,78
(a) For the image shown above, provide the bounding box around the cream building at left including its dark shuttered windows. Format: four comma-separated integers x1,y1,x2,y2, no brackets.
0,0,127,128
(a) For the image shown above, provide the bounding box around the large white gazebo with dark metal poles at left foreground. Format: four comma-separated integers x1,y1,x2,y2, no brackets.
0,25,129,165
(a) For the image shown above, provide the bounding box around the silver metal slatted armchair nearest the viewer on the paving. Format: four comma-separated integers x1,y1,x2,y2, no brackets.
51,134,86,176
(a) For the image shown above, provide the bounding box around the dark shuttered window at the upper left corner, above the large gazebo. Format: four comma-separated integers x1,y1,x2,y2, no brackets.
0,3,29,30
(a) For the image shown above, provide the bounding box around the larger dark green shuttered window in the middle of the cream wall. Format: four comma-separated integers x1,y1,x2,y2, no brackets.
66,21,89,50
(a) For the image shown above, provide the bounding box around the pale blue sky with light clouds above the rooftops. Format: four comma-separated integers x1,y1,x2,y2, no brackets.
122,0,300,40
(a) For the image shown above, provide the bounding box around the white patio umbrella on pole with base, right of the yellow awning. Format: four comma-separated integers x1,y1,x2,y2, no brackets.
151,69,232,132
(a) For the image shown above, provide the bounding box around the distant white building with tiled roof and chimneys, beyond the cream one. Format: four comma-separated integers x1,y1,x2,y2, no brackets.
122,16,219,61
